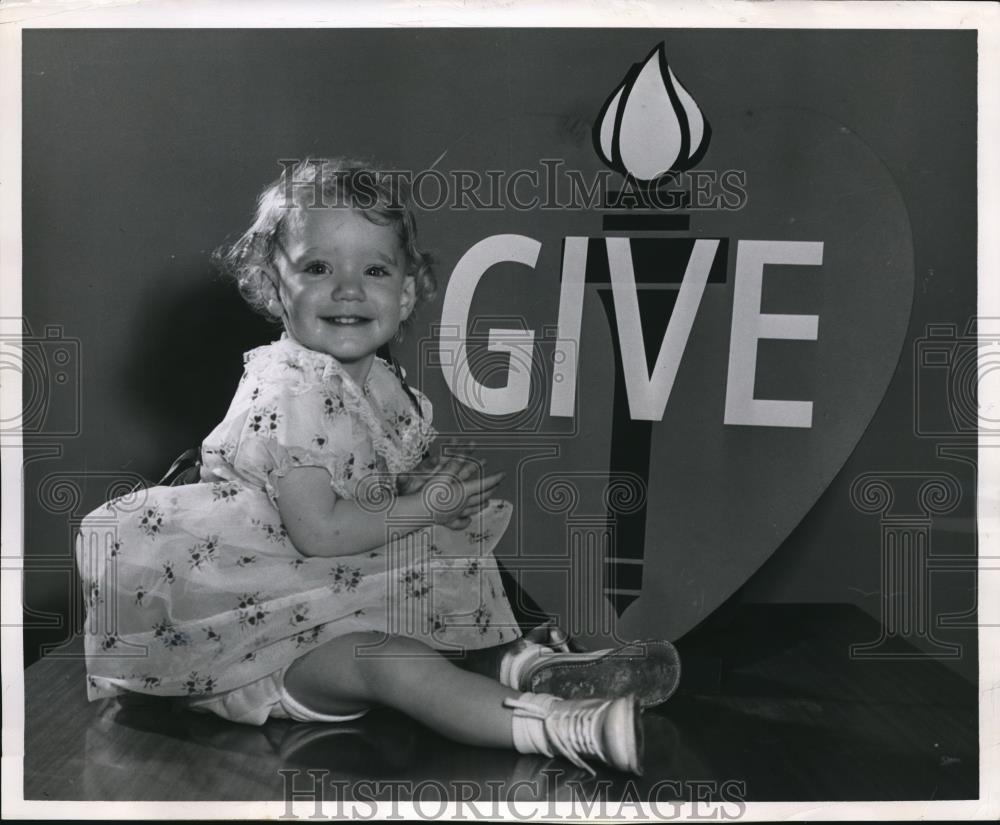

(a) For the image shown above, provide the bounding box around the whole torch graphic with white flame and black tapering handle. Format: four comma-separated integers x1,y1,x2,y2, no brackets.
586,43,728,617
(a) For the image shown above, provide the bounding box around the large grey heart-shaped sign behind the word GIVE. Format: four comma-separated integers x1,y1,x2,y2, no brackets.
426,73,914,643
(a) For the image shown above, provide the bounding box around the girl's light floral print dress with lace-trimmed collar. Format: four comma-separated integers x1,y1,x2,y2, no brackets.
76,336,520,700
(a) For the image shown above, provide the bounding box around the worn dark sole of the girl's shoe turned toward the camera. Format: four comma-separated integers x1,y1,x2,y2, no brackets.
528,640,681,709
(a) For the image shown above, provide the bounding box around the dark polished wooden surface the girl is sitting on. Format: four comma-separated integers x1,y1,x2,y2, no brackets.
24,605,979,801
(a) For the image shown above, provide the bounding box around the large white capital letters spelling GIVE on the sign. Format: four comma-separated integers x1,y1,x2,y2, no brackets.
440,234,823,428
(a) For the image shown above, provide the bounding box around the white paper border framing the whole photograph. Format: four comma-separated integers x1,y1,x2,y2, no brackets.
0,0,1000,821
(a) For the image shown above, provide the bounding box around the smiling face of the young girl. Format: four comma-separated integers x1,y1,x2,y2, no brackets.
275,207,416,384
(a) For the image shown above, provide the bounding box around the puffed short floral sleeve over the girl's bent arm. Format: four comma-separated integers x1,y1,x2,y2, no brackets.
233,372,379,505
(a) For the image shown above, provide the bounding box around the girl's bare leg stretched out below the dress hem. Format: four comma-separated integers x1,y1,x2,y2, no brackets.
285,633,520,748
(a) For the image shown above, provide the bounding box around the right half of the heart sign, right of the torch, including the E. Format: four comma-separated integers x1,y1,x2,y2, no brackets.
617,103,914,636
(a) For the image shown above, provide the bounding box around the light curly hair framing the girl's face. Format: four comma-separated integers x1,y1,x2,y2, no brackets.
212,158,437,338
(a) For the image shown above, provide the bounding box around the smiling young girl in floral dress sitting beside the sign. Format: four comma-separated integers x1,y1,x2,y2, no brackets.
77,160,642,773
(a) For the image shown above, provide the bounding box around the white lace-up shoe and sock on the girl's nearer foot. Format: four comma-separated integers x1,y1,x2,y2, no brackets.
504,693,643,775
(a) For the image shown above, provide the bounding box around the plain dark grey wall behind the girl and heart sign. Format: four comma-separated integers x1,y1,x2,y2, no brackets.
23,30,976,679
